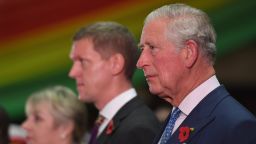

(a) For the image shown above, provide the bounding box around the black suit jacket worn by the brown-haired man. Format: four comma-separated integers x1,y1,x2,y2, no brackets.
97,97,160,144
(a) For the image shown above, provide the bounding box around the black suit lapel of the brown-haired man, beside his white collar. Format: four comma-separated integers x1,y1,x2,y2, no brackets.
98,96,143,143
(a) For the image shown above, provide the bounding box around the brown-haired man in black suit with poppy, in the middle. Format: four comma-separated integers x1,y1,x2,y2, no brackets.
69,22,159,144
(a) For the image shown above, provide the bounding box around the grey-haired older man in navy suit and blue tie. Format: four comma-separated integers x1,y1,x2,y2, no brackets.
137,4,256,144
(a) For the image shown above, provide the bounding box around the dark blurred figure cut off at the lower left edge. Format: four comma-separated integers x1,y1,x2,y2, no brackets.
0,107,10,144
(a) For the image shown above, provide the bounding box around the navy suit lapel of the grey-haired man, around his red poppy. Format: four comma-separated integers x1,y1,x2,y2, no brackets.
167,86,229,144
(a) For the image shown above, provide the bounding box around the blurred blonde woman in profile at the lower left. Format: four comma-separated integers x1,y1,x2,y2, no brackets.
22,86,86,144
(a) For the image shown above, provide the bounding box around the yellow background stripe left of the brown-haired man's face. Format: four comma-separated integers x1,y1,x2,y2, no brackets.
0,42,70,86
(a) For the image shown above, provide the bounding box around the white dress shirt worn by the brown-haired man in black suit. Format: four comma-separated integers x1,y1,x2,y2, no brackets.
98,88,137,136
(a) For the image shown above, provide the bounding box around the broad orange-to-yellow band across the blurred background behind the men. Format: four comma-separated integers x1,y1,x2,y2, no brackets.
0,0,232,86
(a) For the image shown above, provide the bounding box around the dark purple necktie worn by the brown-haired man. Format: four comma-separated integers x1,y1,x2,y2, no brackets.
89,115,104,144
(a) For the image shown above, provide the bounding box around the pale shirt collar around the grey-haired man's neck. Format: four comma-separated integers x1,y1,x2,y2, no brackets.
179,75,220,116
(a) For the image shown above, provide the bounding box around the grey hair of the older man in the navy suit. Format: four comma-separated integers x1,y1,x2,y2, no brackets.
145,4,216,64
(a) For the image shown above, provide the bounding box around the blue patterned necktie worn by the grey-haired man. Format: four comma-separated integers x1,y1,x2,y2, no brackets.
160,108,181,144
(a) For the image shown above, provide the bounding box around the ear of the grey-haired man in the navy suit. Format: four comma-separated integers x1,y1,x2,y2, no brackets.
182,40,199,68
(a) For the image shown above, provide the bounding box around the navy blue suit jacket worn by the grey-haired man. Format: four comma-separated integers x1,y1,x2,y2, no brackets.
154,86,256,144
